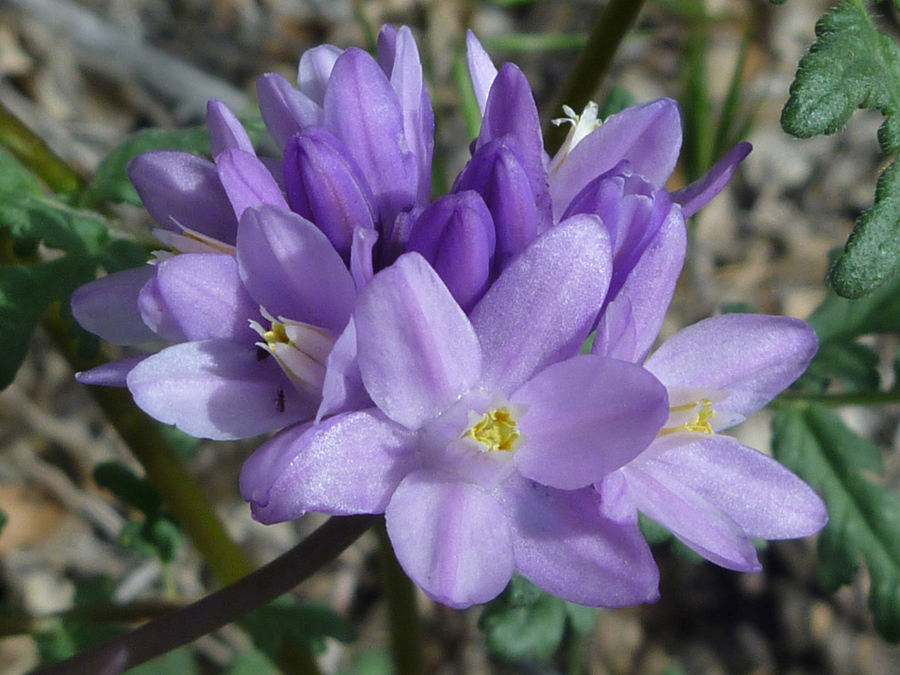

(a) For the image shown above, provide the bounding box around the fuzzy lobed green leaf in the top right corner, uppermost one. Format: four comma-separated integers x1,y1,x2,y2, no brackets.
781,0,900,144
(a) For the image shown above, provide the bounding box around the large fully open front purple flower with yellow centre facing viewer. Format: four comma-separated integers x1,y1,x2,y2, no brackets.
241,216,668,607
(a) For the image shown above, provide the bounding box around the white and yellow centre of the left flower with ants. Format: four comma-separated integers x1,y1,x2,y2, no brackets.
250,308,334,393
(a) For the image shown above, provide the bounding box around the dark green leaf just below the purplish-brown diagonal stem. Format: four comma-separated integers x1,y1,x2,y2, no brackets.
244,600,356,660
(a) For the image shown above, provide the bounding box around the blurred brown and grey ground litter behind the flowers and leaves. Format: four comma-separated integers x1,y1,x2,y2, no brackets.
0,0,900,675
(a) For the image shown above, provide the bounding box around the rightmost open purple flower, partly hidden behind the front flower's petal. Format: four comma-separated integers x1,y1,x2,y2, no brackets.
594,314,828,572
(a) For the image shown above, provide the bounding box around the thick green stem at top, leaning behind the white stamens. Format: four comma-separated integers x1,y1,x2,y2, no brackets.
544,0,645,155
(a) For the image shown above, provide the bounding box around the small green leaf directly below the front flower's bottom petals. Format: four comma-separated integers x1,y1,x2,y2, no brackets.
478,576,567,661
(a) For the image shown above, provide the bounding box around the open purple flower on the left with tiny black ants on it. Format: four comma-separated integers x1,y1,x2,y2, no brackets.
119,205,356,439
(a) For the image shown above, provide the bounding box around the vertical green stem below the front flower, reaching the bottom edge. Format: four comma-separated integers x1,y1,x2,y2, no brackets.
375,520,424,675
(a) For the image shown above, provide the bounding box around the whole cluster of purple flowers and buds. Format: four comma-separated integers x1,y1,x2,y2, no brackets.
73,27,827,607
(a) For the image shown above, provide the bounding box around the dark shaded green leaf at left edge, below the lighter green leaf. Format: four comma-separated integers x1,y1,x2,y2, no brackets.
0,254,95,389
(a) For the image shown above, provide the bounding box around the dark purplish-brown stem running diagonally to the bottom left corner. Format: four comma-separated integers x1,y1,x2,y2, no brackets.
35,516,376,675
